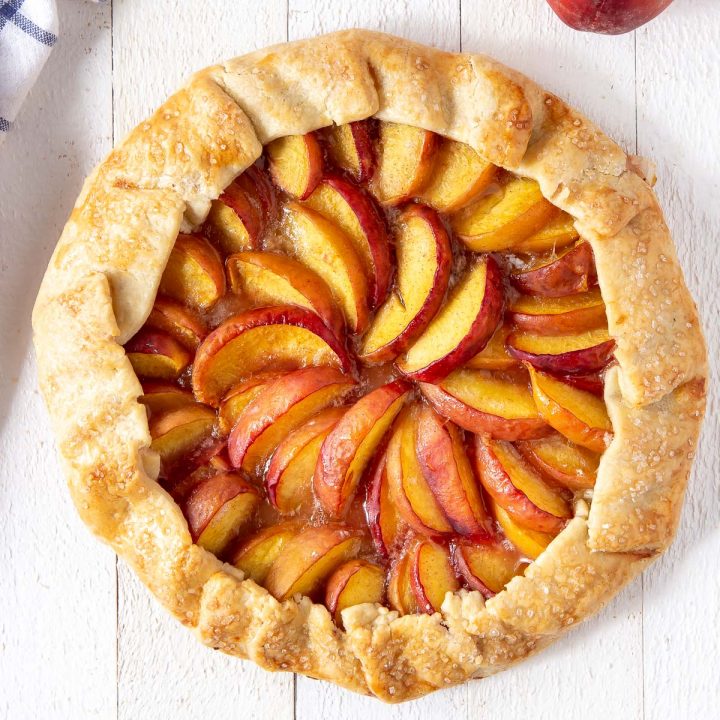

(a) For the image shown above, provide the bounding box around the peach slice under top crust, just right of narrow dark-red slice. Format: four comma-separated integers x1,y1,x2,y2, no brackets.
370,122,438,205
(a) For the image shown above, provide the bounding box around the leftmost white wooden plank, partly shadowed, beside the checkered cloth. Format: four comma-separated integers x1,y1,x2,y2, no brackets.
0,0,116,720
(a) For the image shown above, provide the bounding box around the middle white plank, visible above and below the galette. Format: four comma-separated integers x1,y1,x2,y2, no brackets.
288,0,468,720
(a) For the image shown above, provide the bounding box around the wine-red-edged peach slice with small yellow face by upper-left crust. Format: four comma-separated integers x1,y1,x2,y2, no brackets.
205,176,265,254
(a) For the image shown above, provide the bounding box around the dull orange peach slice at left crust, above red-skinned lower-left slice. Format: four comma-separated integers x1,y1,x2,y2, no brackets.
149,402,215,476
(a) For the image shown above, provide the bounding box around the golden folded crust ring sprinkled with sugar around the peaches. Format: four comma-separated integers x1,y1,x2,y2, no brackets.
33,30,707,702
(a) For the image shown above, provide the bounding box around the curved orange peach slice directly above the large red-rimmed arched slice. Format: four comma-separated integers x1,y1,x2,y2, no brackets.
226,252,344,337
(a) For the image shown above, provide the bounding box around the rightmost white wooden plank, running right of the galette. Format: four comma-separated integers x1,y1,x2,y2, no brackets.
637,0,720,720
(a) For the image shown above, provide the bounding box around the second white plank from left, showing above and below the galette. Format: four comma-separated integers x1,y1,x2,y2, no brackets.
113,0,293,720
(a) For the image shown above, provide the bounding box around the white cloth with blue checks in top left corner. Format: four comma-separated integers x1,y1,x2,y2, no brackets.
0,0,104,143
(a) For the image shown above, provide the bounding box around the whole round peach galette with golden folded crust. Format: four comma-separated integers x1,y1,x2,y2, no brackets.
34,31,705,701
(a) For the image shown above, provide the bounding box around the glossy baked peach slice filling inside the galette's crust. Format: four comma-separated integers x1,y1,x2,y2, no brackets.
126,120,614,624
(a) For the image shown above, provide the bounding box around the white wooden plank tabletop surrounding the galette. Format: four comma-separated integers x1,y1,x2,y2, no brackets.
0,0,720,720
